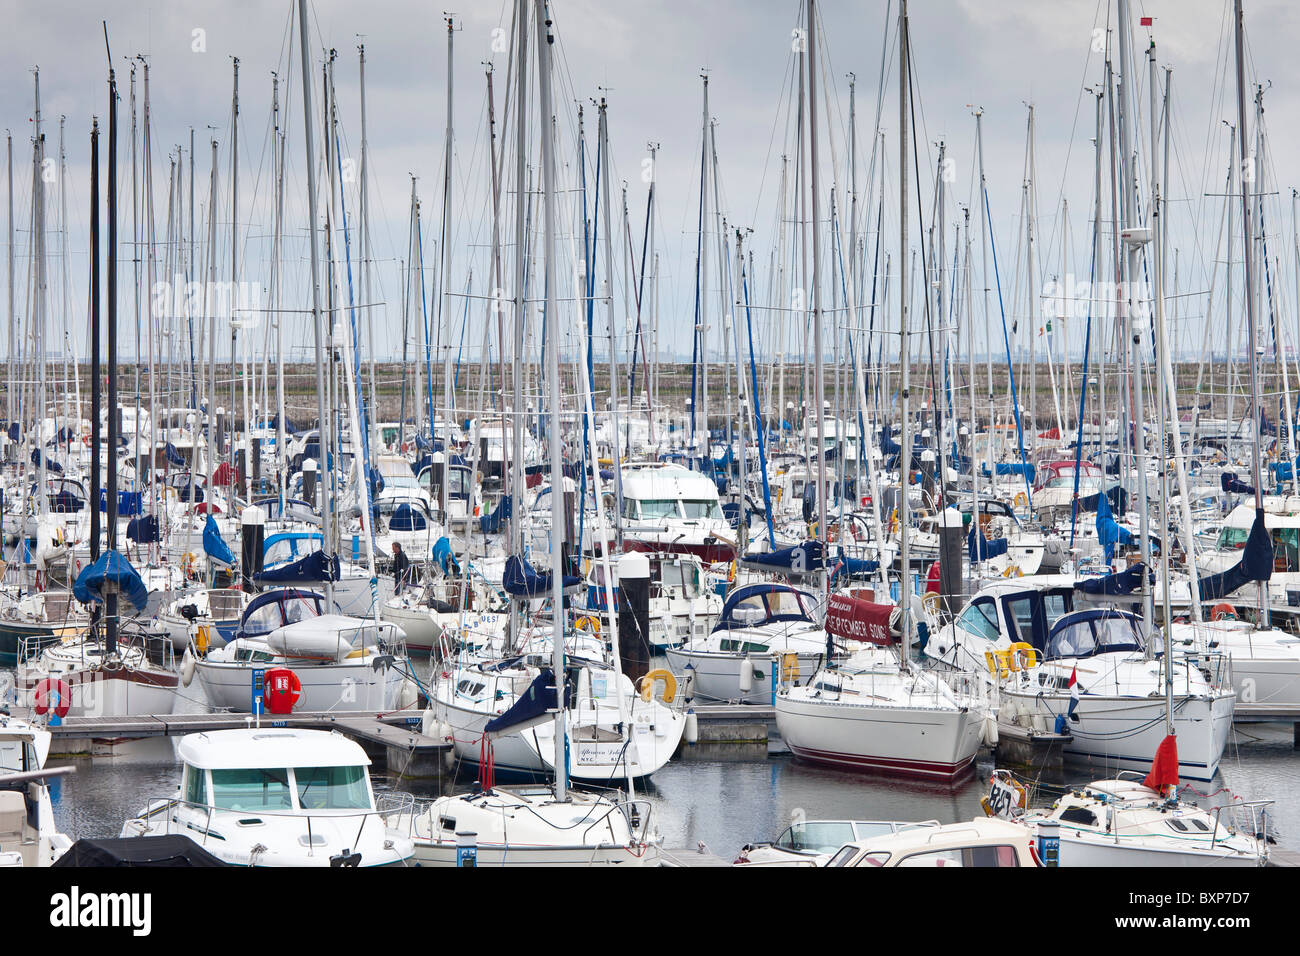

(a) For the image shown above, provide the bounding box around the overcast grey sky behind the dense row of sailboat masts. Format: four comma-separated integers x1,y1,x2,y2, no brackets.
0,0,1300,377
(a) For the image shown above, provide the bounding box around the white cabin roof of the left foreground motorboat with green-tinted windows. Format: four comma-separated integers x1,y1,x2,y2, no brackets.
177,727,371,770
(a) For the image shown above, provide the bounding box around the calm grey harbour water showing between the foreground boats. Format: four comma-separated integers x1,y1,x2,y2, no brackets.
51,723,1300,860
